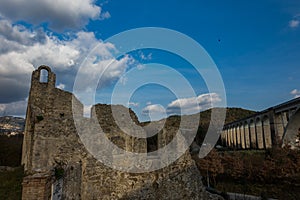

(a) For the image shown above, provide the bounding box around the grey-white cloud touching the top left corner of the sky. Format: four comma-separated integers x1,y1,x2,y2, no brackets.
0,0,102,30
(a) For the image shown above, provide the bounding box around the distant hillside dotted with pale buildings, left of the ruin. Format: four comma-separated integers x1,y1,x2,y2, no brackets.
0,116,25,136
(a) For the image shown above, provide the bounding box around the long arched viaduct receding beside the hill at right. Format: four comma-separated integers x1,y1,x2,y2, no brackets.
220,97,300,149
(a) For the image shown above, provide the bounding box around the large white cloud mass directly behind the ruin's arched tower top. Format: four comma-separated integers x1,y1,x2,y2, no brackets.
0,19,132,108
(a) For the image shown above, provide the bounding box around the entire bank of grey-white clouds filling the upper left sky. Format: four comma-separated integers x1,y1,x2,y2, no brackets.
0,0,129,115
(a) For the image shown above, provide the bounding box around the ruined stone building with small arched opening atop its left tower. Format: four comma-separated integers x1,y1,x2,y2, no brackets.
22,66,218,200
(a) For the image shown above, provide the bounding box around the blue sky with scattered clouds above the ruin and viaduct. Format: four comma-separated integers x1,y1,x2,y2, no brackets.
0,0,300,120
